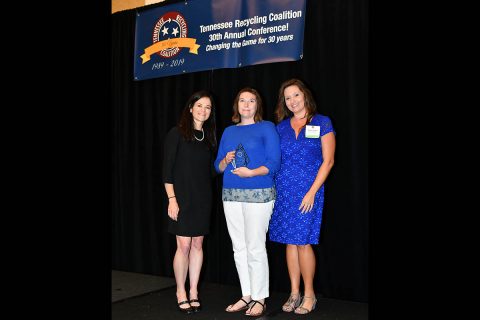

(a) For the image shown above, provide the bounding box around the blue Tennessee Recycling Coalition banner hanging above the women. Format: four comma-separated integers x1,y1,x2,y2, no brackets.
134,0,306,80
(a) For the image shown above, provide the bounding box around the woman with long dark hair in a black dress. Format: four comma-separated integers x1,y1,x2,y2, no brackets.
163,91,217,313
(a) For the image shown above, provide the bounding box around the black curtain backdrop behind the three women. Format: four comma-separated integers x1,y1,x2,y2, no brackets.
111,0,369,302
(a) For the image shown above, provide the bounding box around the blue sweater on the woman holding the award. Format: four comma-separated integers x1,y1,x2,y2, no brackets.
215,120,280,189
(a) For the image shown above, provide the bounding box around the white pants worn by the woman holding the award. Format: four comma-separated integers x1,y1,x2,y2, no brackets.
223,200,275,300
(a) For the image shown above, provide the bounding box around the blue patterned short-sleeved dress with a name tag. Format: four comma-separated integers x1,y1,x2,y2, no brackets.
269,114,335,245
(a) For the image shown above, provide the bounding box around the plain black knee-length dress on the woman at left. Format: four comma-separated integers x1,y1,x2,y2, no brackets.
163,127,215,237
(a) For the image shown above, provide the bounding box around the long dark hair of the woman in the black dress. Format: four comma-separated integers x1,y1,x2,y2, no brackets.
178,90,217,150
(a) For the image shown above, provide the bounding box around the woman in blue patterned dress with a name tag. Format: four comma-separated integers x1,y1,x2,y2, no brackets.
269,79,335,314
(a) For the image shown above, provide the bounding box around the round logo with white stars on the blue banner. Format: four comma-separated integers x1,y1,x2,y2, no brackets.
153,11,188,58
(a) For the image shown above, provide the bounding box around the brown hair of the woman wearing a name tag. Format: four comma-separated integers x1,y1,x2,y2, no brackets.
275,78,317,123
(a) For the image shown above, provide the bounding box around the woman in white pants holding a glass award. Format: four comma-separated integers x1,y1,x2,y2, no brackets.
215,87,280,317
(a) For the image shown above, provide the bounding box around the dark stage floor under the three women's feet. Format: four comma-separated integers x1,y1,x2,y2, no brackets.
112,271,368,320
